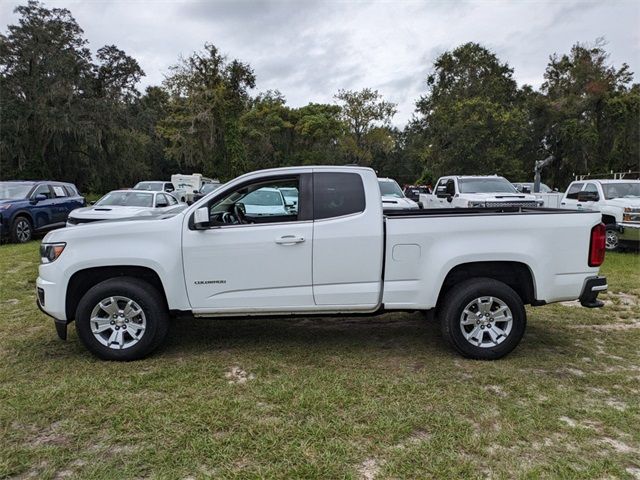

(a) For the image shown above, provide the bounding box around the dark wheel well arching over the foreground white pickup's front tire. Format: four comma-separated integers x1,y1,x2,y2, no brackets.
65,266,167,321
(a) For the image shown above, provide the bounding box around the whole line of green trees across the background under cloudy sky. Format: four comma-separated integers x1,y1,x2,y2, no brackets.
0,1,640,192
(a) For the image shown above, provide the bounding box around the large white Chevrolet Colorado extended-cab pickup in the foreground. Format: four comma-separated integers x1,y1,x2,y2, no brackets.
36,167,607,360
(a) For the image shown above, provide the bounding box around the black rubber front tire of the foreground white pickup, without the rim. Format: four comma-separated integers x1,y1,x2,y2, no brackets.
75,277,169,361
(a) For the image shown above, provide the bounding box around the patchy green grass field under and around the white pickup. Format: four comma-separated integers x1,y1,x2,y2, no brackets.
0,242,640,479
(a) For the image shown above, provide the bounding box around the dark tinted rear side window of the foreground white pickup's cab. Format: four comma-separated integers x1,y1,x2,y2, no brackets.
313,172,365,220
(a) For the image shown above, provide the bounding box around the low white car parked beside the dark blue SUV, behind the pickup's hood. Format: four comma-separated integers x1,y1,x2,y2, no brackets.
67,190,187,227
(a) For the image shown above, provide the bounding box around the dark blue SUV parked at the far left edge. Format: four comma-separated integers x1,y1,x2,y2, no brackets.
0,180,85,243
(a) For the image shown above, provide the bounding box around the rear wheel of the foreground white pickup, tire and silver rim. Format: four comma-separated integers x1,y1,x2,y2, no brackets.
439,278,527,360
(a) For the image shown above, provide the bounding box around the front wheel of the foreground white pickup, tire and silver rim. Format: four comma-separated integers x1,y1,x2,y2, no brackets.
76,277,169,361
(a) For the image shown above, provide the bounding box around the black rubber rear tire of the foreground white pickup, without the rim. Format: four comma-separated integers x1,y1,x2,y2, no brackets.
438,278,527,360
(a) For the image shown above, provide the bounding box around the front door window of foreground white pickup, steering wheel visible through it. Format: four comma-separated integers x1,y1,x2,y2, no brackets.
209,177,299,225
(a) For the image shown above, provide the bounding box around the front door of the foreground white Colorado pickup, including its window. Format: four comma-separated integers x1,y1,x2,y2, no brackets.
183,174,314,314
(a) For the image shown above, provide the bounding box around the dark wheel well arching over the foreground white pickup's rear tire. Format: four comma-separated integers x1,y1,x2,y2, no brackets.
438,262,536,305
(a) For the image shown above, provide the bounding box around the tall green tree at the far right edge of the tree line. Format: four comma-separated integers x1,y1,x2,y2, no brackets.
539,39,640,185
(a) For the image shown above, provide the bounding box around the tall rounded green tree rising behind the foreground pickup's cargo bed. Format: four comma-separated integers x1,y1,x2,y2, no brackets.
411,43,530,180
